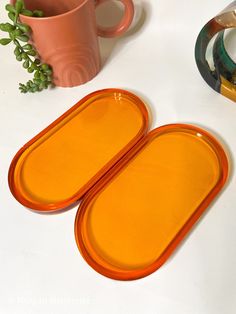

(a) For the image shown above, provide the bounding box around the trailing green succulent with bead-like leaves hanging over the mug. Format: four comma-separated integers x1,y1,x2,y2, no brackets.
0,0,52,93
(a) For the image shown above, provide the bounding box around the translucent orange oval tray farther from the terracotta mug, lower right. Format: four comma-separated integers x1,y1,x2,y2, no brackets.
75,125,228,280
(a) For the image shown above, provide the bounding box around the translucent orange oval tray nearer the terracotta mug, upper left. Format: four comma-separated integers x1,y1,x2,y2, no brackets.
9,89,148,211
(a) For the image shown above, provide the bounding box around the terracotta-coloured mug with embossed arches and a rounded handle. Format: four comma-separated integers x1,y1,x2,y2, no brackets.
10,0,134,87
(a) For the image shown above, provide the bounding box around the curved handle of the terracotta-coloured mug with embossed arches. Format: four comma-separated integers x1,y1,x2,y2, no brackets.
95,0,134,38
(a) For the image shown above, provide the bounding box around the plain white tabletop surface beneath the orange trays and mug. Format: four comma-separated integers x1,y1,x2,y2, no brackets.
0,0,236,314
